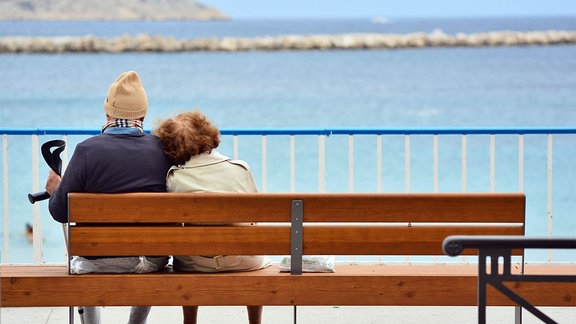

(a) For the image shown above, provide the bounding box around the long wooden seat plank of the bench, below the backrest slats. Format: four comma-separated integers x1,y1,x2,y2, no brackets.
0,265,576,307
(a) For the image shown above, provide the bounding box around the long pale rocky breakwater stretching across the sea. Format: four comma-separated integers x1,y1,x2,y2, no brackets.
0,31,576,53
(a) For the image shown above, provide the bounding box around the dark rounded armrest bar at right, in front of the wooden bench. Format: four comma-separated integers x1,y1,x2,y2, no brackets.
442,235,576,256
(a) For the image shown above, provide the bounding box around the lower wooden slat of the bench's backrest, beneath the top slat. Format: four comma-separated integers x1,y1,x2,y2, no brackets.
70,224,524,256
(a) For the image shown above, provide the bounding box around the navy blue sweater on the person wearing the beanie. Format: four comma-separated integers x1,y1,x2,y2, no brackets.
49,133,171,223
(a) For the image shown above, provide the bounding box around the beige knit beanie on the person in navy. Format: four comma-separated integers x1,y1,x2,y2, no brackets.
104,71,148,119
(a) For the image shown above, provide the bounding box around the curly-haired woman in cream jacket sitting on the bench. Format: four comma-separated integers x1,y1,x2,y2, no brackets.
154,110,271,324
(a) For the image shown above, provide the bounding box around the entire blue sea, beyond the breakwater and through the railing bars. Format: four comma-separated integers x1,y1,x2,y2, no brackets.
0,17,576,263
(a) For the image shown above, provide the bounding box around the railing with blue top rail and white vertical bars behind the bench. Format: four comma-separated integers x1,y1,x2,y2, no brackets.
0,127,576,263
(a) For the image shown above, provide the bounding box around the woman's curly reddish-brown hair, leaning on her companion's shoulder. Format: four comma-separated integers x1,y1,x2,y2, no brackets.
153,110,220,165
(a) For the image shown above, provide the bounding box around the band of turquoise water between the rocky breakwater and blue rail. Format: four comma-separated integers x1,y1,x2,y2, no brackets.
0,46,576,128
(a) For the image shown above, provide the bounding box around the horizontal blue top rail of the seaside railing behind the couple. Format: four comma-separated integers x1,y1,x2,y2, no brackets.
0,127,576,136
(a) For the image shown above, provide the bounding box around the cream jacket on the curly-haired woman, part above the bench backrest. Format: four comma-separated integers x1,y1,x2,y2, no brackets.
166,150,258,192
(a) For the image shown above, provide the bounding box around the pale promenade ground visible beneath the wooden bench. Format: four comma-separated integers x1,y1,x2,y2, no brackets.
0,306,576,324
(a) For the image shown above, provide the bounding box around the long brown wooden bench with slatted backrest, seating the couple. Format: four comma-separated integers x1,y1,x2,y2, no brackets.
1,193,576,322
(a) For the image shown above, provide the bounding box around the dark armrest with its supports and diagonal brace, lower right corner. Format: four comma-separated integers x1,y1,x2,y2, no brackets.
442,236,576,324
